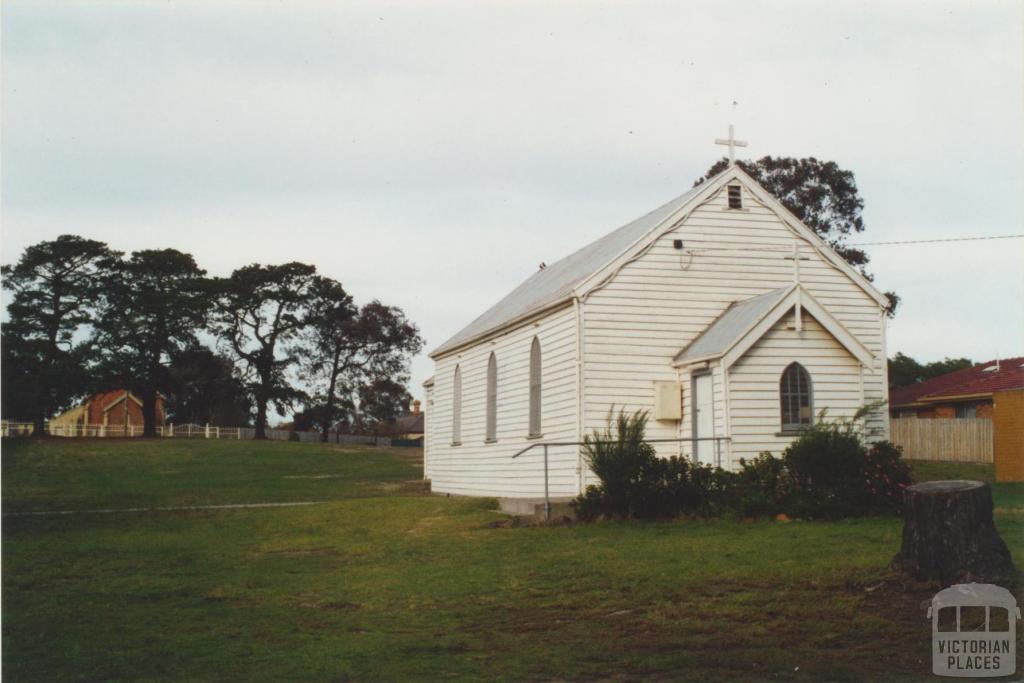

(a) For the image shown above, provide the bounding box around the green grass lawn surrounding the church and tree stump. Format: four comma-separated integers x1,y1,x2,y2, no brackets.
2,439,1024,681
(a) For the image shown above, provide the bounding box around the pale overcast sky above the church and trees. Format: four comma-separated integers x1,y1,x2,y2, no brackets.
0,0,1024,405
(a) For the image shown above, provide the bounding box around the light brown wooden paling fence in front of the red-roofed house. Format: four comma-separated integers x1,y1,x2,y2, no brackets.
889,418,993,463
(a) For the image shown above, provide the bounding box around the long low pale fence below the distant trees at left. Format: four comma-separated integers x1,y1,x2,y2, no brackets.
0,420,391,446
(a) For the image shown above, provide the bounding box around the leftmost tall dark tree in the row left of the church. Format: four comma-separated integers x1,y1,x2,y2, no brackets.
0,234,118,436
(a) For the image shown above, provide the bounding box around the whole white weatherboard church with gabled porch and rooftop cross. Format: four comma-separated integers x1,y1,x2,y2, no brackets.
424,130,889,498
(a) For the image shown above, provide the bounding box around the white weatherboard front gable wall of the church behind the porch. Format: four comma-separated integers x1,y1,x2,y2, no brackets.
583,181,889,471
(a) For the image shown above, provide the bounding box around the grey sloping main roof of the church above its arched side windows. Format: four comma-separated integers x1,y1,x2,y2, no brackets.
431,184,707,355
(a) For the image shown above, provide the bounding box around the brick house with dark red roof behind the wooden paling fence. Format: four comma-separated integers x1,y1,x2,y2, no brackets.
889,356,1024,420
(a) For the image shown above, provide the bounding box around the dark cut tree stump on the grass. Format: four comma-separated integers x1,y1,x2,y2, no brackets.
893,480,1015,586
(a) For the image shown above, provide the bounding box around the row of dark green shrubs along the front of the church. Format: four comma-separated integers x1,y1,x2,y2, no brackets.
572,407,911,520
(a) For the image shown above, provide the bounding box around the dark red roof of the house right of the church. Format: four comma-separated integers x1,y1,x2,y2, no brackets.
889,356,1024,408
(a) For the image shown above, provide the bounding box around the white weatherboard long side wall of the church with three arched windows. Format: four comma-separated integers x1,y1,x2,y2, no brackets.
425,305,579,498
